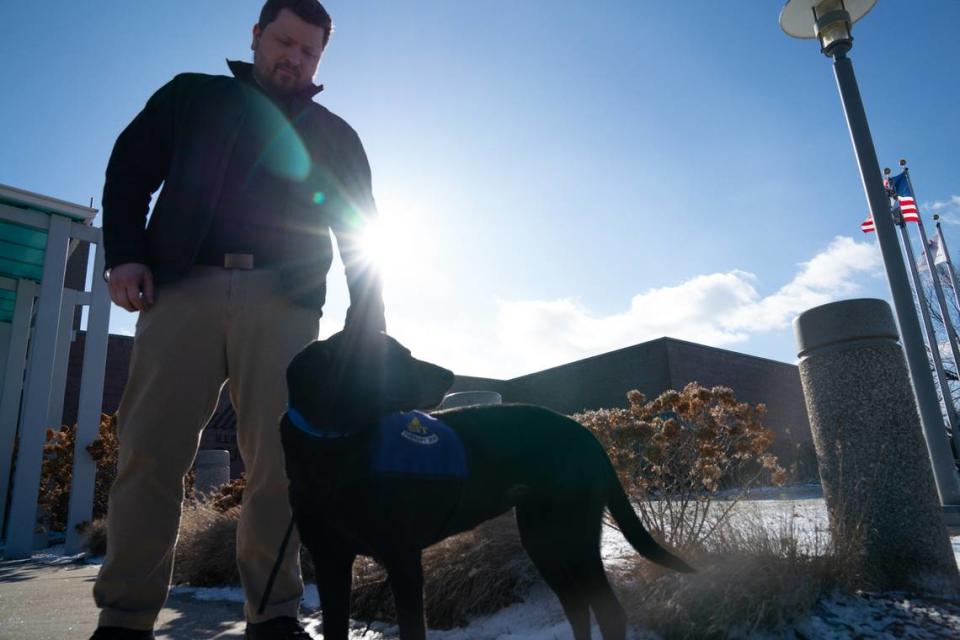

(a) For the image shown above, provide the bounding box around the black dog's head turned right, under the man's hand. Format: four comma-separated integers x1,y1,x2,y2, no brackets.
287,331,453,433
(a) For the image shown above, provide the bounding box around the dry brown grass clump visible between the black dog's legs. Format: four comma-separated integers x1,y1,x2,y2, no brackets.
352,514,536,629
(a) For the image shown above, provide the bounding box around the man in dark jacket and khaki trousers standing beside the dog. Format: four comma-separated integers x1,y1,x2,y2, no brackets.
93,0,384,640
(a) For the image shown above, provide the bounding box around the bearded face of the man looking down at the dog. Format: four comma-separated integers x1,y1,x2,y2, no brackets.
250,9,324,94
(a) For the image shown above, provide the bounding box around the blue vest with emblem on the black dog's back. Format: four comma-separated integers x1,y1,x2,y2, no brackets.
370,411,467,478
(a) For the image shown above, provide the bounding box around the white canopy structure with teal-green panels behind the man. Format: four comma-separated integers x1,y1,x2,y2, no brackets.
0,184,110,559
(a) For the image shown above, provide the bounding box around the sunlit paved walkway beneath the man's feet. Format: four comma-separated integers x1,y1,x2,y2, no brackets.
0,559,319,640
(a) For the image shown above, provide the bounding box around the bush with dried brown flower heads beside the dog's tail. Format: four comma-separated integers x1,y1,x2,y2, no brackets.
573,382,786,547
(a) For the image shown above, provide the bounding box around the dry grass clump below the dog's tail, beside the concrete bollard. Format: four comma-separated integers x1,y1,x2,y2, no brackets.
618,508,849,640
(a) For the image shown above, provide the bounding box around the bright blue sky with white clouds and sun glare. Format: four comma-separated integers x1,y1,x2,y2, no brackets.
0,0,960,377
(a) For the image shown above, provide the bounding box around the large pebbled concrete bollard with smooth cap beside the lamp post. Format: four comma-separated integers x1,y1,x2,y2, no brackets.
793,299,960,597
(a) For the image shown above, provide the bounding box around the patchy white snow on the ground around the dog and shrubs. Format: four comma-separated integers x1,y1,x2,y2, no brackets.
41,486,960,640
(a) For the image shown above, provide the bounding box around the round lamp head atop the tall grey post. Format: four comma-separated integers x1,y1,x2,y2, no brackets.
780,0,877,56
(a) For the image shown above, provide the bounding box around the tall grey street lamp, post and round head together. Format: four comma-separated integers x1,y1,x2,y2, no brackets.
780,0,960,507
